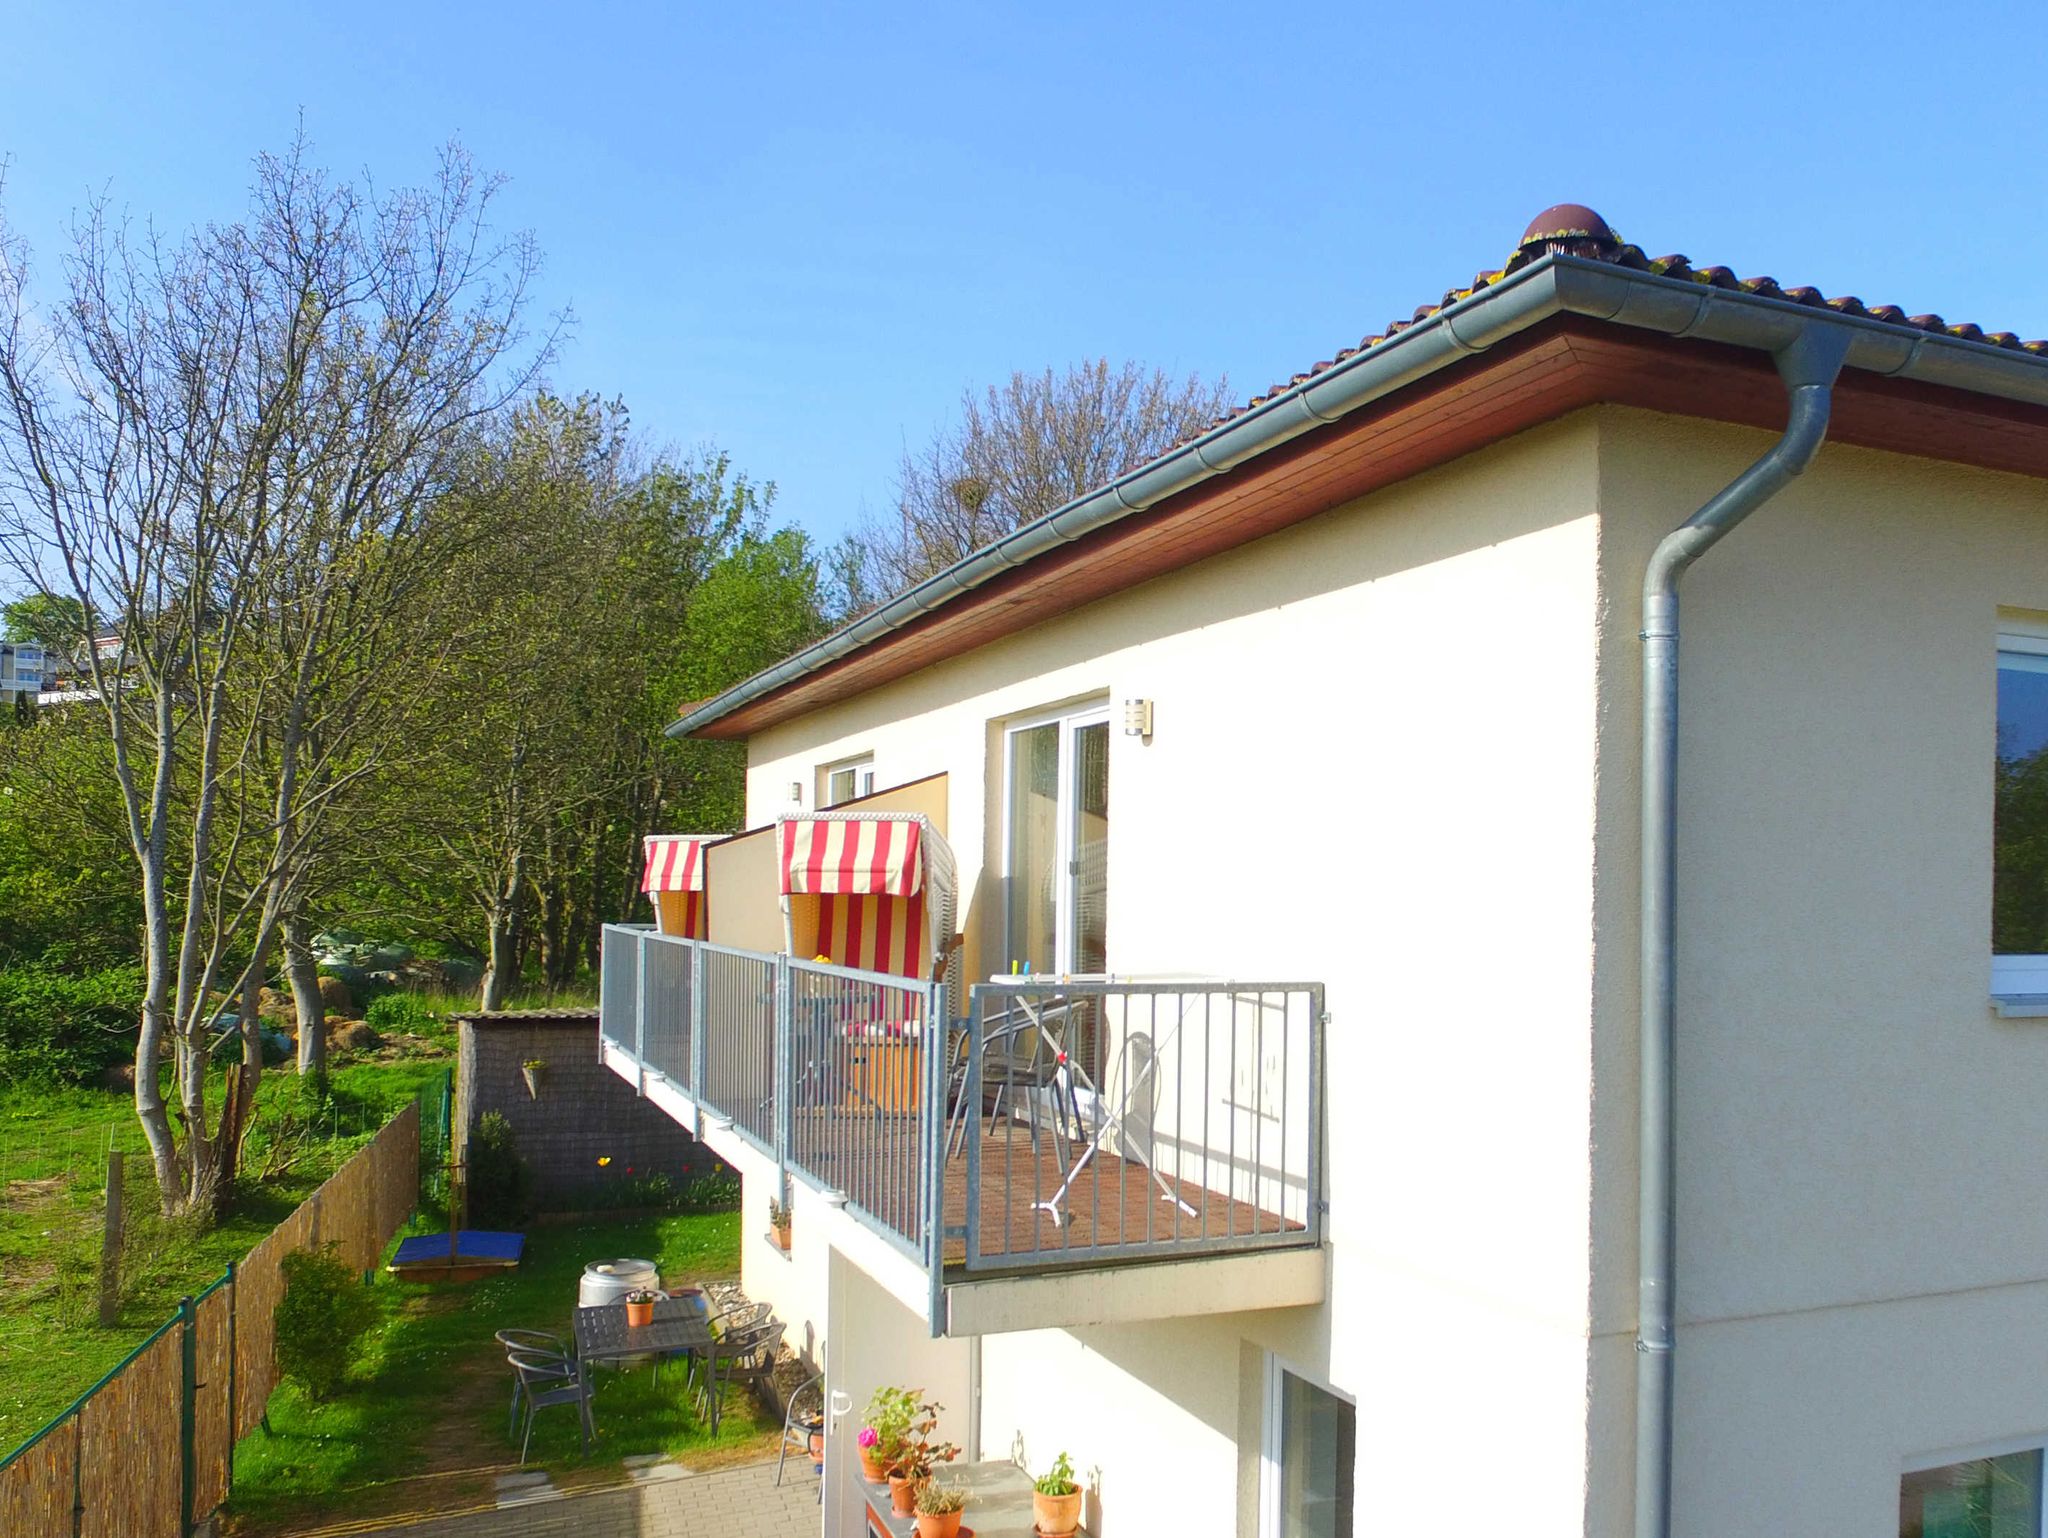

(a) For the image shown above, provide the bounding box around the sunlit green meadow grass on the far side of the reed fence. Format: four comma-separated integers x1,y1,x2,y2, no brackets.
0,1059,446,1454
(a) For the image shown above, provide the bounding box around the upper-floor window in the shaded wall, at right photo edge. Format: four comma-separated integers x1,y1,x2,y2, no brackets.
1991,629,2048,997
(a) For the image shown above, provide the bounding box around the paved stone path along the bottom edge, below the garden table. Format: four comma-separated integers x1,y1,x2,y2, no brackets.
333,1458,821,1538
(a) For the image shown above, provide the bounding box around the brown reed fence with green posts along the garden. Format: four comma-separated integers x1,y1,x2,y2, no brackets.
0,1102,420,1538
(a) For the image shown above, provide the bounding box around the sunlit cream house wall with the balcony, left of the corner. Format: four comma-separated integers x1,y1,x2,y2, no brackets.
748,414,1599,1538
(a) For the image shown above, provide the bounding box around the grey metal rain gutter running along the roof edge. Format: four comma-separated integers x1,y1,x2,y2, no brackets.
668,256,2048,737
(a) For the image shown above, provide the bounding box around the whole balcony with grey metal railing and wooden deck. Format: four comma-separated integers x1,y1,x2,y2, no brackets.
602,926,1325,1335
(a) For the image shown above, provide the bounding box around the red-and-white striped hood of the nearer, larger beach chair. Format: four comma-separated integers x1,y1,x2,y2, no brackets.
778,811,958,977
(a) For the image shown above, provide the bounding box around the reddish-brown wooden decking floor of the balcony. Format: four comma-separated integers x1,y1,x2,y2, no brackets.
791,1108,1305,1270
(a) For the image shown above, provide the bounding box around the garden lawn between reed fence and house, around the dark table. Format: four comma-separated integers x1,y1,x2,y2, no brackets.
227,1212,780,1534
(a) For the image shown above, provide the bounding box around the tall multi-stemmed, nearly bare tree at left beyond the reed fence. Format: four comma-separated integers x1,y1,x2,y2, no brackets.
0,143,537,1212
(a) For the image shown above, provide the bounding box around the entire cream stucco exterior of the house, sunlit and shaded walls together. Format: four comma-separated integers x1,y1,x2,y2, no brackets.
663,408,2048,1538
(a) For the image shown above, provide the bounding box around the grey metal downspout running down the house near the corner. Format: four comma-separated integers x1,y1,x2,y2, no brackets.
1636,326,1849,1538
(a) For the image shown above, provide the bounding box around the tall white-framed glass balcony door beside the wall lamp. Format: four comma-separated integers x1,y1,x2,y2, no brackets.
1004,704,1110,973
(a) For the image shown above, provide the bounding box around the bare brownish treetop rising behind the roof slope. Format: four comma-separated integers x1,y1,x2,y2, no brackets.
836,358,1229,610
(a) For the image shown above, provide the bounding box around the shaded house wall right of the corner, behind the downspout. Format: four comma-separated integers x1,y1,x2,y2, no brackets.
1593,410,2048,1538
